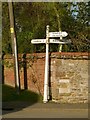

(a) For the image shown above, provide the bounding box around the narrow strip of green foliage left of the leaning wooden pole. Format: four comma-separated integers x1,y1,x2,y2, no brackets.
2,3,12,53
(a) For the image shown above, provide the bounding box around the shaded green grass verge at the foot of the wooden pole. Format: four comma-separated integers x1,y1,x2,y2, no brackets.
2,85,42,103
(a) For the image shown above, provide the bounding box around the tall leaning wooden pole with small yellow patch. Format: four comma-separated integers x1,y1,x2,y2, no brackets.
8,0,20,92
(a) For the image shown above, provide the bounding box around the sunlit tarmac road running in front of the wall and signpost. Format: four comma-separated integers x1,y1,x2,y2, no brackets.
2,103,88,118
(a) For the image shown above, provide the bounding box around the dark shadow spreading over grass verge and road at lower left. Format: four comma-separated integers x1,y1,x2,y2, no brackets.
2,85,42,115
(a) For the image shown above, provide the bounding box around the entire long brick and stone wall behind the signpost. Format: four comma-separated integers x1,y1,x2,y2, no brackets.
4,53,90,103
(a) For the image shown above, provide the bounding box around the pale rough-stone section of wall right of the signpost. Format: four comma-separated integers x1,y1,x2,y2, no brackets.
51,59,88,103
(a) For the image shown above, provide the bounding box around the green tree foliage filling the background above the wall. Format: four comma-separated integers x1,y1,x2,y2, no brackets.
2,2,90,53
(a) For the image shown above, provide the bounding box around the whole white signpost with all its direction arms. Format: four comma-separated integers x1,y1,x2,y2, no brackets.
31,25,70,103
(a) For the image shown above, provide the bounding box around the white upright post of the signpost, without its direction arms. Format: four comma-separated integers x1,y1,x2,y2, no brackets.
43,25,49,103
